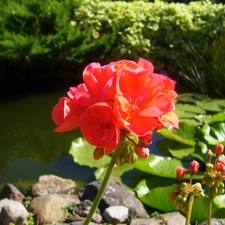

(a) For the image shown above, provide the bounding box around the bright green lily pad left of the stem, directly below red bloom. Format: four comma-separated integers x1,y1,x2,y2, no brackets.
69,137,111,168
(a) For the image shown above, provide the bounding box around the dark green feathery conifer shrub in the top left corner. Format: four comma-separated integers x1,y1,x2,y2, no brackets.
0,0,116,81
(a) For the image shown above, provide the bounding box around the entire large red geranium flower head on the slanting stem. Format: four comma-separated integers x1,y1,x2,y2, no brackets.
52,58,178,154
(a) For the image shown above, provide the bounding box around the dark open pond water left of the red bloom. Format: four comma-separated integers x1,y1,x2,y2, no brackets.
0,90,94,192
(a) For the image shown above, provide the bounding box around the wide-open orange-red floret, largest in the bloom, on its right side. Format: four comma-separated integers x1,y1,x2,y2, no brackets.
114,68,173,136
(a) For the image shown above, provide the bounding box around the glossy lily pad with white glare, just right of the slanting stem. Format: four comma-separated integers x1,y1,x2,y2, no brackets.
134,154,182,178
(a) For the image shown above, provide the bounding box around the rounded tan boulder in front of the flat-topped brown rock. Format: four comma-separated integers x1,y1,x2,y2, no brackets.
27,194,68,225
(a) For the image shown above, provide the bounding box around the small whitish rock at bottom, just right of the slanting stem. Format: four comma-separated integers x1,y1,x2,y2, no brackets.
103,206,129,224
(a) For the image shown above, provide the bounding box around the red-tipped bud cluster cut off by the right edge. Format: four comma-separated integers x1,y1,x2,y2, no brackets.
202,144,225,196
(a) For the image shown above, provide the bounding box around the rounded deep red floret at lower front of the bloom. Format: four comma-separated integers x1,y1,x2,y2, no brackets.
79,102,120,154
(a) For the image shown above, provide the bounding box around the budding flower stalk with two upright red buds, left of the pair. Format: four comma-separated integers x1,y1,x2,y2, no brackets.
169,160,204,225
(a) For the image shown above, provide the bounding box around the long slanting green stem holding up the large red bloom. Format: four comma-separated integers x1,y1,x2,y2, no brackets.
84,147,119,225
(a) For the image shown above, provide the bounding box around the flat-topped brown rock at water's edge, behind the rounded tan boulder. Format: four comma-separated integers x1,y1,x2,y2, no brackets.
31,175,76,196
